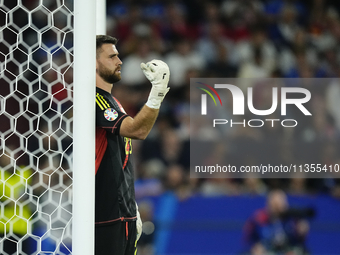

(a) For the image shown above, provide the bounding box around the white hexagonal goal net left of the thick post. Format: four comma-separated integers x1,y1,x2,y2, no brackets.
0,0,73,255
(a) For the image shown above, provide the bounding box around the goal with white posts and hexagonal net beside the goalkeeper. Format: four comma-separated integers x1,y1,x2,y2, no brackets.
0,0,106,255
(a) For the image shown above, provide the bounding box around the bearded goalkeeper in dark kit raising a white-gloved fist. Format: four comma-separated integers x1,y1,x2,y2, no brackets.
95,35,170,255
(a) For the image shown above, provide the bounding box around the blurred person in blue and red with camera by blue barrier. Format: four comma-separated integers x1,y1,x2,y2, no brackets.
244,190,311,255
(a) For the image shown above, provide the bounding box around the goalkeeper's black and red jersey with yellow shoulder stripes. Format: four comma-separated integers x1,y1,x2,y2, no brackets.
95,88,136,224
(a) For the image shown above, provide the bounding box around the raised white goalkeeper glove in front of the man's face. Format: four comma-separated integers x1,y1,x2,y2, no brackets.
140,59,170,109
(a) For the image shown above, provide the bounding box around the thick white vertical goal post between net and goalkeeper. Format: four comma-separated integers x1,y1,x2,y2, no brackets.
72,0,95,255
